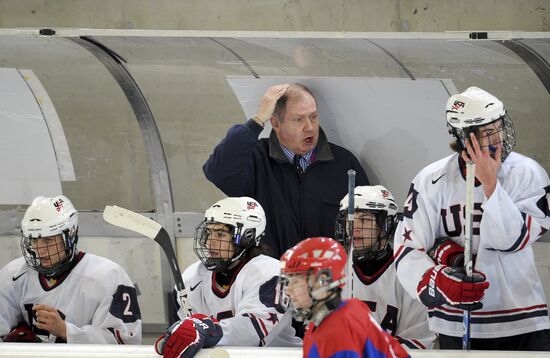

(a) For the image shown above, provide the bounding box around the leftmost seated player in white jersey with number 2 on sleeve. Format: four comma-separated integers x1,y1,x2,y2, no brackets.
0,195,141,344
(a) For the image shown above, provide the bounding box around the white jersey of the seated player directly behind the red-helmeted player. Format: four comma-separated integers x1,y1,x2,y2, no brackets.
344,258,436,349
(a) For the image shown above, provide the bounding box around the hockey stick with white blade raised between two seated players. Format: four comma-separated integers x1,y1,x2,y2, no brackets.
103,205,191,317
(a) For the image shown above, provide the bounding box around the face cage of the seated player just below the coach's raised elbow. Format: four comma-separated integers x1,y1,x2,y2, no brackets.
193,220,259,272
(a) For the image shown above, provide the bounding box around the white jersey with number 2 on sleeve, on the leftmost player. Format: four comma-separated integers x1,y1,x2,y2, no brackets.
0,252,141,344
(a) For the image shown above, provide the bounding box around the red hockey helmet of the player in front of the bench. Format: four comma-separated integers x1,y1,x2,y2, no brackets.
281,237,347,288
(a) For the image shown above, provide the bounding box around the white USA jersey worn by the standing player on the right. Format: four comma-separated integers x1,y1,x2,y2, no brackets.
394,152,550,338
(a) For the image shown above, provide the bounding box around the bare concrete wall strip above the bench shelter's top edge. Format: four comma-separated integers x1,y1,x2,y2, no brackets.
0,0,550,32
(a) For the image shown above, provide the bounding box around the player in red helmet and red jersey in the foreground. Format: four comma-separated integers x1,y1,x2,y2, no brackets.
280,237,408,357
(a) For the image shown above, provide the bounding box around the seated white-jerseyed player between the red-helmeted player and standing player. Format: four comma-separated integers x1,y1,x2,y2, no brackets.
336,185,436,349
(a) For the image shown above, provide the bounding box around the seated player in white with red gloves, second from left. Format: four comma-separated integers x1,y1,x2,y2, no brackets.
157,197,301,357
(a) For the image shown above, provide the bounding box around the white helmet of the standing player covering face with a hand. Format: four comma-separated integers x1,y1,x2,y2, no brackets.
446,87,516,161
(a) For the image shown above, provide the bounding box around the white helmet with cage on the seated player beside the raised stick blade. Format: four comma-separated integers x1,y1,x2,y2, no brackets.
193,196,266,271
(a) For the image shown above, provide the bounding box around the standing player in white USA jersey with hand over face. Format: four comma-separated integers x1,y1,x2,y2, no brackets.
394,87,550,350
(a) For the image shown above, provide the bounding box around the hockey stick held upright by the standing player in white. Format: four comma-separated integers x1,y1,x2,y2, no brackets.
462,162,476,350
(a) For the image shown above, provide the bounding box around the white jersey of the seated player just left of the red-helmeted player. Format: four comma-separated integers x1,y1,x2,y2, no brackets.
178,255,301,347
